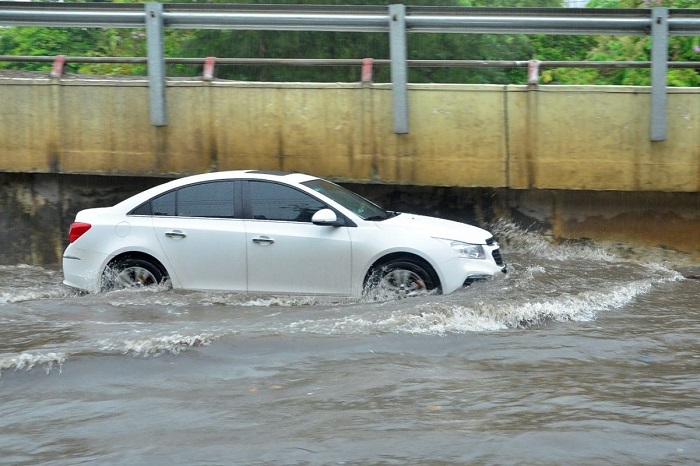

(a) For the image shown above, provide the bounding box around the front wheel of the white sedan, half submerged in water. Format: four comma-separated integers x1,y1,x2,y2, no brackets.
365,258,439,299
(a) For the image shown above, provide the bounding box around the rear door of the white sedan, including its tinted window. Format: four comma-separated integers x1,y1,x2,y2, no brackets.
151,181,247,291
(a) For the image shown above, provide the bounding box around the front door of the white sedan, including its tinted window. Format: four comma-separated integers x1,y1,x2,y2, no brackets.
244,181,351,296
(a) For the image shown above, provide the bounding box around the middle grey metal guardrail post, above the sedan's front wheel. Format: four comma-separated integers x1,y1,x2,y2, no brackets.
389,4,408,134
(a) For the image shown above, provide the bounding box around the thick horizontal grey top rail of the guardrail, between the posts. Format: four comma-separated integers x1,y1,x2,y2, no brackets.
0,2,700,35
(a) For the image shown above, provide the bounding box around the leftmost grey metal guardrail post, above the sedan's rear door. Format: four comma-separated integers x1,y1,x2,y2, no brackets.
146,3,168,126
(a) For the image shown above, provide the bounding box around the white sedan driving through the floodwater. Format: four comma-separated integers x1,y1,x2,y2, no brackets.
63,170,506,297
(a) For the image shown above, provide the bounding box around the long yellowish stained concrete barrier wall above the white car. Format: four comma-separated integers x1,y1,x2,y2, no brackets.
0,78,700,192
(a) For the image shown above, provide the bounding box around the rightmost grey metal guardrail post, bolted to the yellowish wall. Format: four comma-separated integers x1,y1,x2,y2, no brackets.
651,7,668,141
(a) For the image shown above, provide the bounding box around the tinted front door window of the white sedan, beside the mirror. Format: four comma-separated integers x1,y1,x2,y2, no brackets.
248,181,326,222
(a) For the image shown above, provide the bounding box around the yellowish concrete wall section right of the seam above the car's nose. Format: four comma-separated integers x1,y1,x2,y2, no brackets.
508,86,700,192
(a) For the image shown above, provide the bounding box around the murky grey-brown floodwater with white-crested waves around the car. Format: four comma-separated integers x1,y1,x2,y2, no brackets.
0,225,700,465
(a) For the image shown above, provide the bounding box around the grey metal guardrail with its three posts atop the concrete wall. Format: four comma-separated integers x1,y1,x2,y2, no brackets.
0,2,700,141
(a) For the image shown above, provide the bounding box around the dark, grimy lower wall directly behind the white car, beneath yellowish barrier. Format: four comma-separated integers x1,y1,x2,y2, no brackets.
0,173,700,265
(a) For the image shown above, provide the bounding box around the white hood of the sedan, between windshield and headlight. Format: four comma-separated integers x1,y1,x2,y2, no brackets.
376,214,493,244
